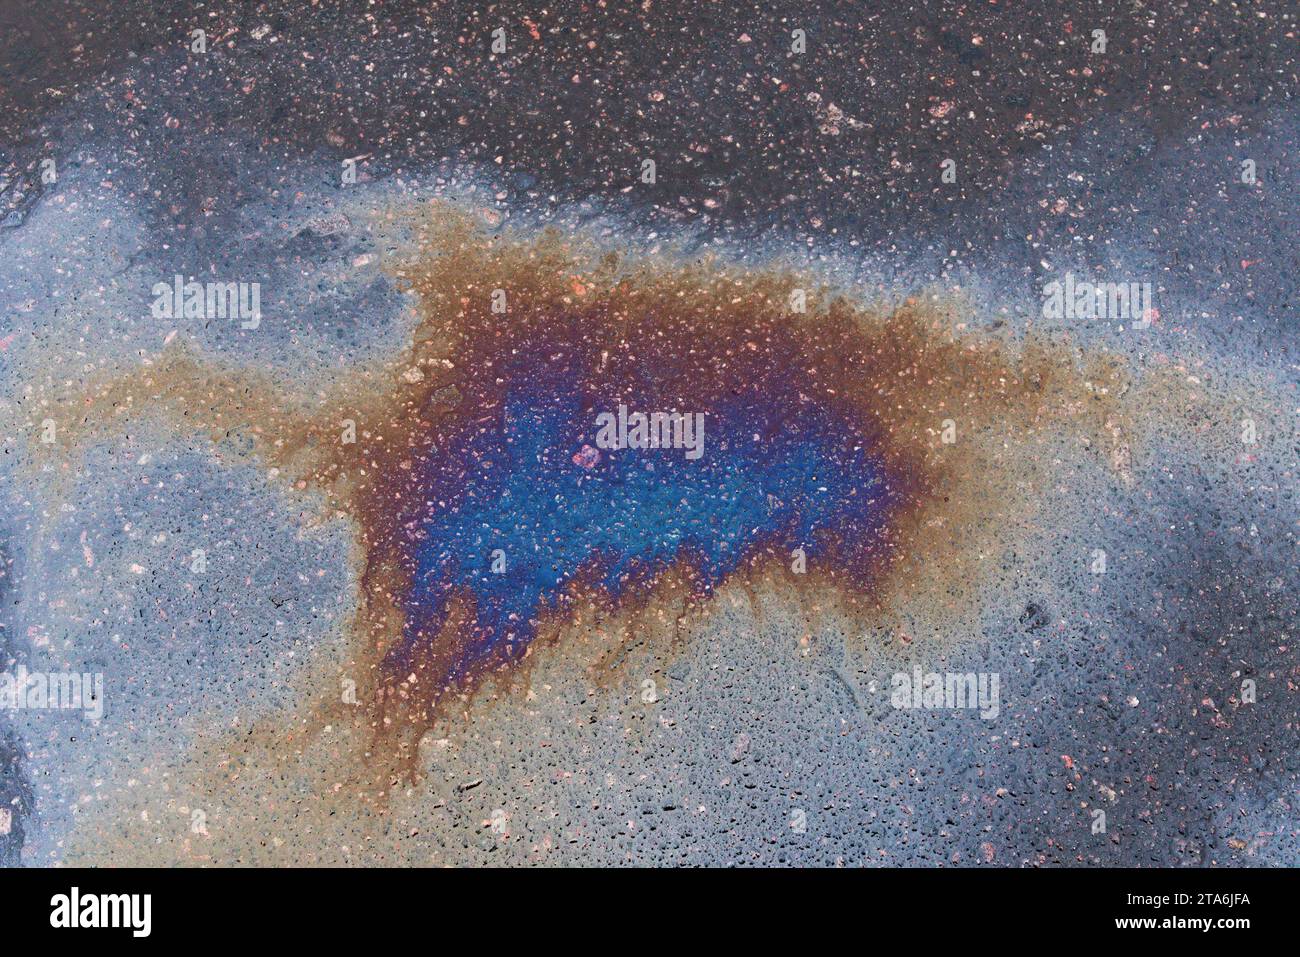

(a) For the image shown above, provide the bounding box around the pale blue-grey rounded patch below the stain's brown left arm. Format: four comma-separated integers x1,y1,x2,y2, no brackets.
4,433,354,863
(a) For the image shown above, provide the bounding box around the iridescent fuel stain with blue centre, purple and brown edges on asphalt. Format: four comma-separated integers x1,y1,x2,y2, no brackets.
35,204,1132,780
